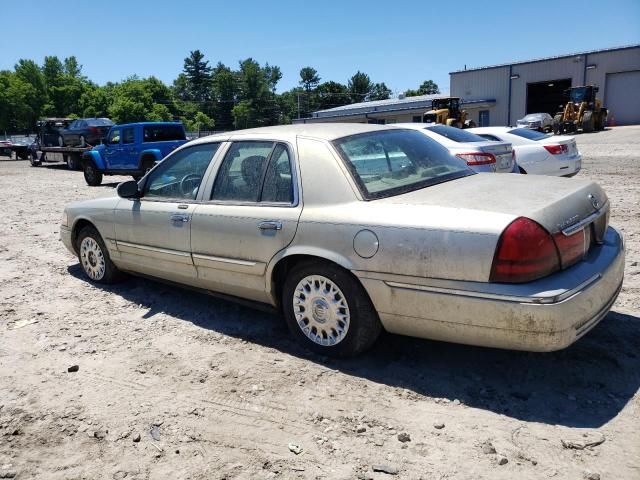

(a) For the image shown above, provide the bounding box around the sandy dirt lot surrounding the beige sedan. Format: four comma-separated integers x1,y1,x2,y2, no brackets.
0,127,640,480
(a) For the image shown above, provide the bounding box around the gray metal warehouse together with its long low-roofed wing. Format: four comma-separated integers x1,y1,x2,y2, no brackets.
294,45,640,126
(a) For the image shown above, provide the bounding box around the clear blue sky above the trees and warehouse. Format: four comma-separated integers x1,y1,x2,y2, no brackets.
0,0,640,93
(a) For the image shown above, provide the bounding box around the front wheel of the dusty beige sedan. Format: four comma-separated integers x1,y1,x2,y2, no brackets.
76,225,124,284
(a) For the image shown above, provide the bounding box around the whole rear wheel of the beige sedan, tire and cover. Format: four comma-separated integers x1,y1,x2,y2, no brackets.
282,262,382,357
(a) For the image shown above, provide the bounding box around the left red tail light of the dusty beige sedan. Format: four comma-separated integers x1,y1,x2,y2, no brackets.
489,217,560,283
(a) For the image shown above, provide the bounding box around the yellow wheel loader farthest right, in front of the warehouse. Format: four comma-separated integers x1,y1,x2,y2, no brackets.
553,85,608,134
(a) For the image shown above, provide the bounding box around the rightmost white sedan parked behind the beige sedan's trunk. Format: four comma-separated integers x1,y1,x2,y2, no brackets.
468,127,582,177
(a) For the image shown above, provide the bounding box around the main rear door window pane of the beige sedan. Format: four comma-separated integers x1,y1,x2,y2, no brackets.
211,142,273,202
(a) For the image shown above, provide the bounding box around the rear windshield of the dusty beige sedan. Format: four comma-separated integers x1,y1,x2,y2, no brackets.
333,129,473,200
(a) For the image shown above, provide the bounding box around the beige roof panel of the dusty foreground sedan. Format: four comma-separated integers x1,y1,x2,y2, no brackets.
186,123,392,145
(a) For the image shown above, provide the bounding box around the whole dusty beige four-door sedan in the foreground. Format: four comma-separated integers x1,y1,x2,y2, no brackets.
61,124,624,355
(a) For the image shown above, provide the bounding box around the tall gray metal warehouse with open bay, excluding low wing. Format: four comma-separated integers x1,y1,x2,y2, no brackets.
450,45,640,125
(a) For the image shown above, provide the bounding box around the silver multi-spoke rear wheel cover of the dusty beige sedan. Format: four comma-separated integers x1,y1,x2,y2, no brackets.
293,275,351,347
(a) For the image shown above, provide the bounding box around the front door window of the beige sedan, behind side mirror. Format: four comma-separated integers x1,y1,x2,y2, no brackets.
143,143,220,200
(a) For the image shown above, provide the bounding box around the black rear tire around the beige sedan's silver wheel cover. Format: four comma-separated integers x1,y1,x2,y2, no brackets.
282,261,382,357
